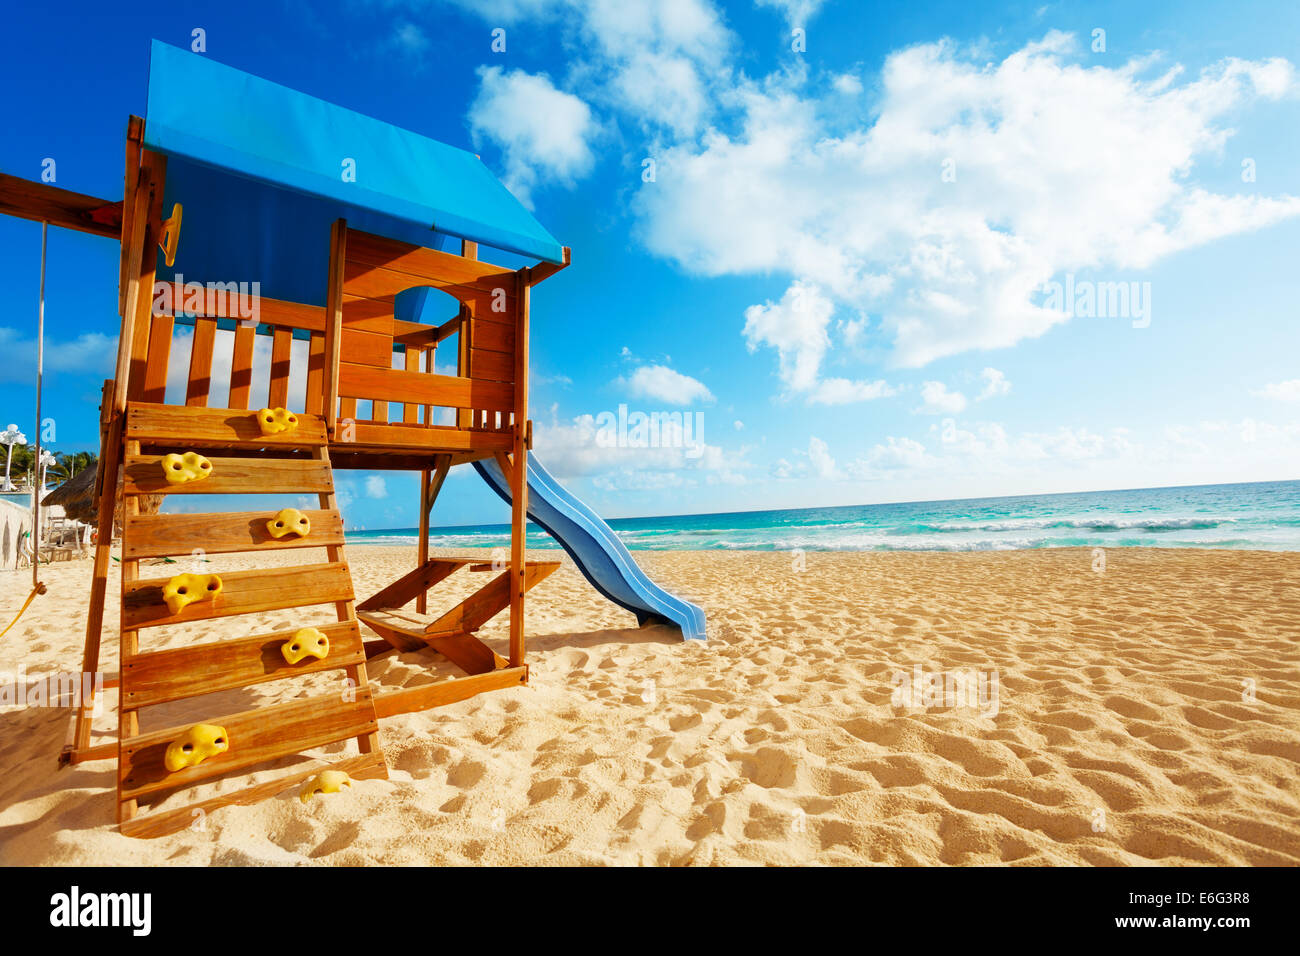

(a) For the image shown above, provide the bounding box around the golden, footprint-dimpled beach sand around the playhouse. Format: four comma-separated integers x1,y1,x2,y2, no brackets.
0,546,1300,865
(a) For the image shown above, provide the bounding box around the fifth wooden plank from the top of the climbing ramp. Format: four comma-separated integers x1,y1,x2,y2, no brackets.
122,620,365,709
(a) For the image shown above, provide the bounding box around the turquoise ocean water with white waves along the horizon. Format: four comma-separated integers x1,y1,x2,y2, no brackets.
347,481,1300,551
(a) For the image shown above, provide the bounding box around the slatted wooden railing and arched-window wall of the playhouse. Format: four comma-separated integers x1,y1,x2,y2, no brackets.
139,230,523,450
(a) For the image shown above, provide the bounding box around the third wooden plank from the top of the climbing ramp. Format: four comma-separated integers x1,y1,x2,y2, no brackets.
122,510,343,559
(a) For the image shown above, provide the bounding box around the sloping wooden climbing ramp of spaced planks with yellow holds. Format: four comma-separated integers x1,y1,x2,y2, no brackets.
109,402,387,836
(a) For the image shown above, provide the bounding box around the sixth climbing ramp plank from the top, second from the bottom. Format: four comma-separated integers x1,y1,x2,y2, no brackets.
117,688,378,803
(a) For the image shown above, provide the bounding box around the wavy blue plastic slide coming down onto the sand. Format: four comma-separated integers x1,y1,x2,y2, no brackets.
475,453,705,641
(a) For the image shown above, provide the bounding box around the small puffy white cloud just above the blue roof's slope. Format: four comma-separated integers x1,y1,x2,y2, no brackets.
468,66,597,206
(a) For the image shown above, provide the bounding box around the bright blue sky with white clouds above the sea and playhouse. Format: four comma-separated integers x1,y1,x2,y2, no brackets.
0,0,1300,528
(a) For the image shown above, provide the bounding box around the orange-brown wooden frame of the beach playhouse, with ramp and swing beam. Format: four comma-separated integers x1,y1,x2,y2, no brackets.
0,69,568,836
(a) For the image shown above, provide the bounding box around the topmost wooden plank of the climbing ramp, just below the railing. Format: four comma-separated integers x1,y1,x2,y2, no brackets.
126,402,326,449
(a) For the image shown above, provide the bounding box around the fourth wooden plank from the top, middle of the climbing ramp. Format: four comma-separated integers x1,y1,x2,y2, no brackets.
122,562,352,631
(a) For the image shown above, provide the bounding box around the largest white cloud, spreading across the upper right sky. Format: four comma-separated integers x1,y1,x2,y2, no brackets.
636,31,1300,366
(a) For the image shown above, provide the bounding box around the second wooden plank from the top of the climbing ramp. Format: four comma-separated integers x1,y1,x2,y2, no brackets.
124,455,334,494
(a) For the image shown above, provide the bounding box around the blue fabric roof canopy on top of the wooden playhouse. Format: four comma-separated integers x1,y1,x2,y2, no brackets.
144,40,563,304
